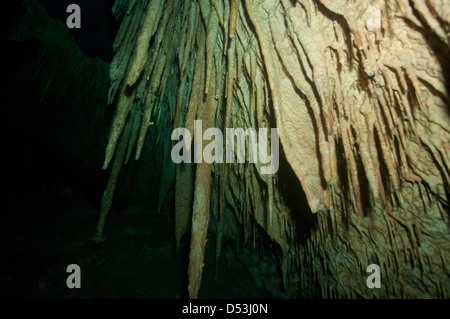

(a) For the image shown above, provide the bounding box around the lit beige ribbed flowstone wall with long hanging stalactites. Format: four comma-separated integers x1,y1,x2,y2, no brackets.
97,0,450,298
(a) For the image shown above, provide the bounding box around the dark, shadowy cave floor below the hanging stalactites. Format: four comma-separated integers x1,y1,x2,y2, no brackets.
0,188,271,299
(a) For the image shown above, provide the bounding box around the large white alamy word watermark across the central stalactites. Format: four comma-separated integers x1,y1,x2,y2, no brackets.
171,120,280,174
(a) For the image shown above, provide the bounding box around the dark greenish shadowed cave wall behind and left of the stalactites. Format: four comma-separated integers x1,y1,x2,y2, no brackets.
2,1,113,202
